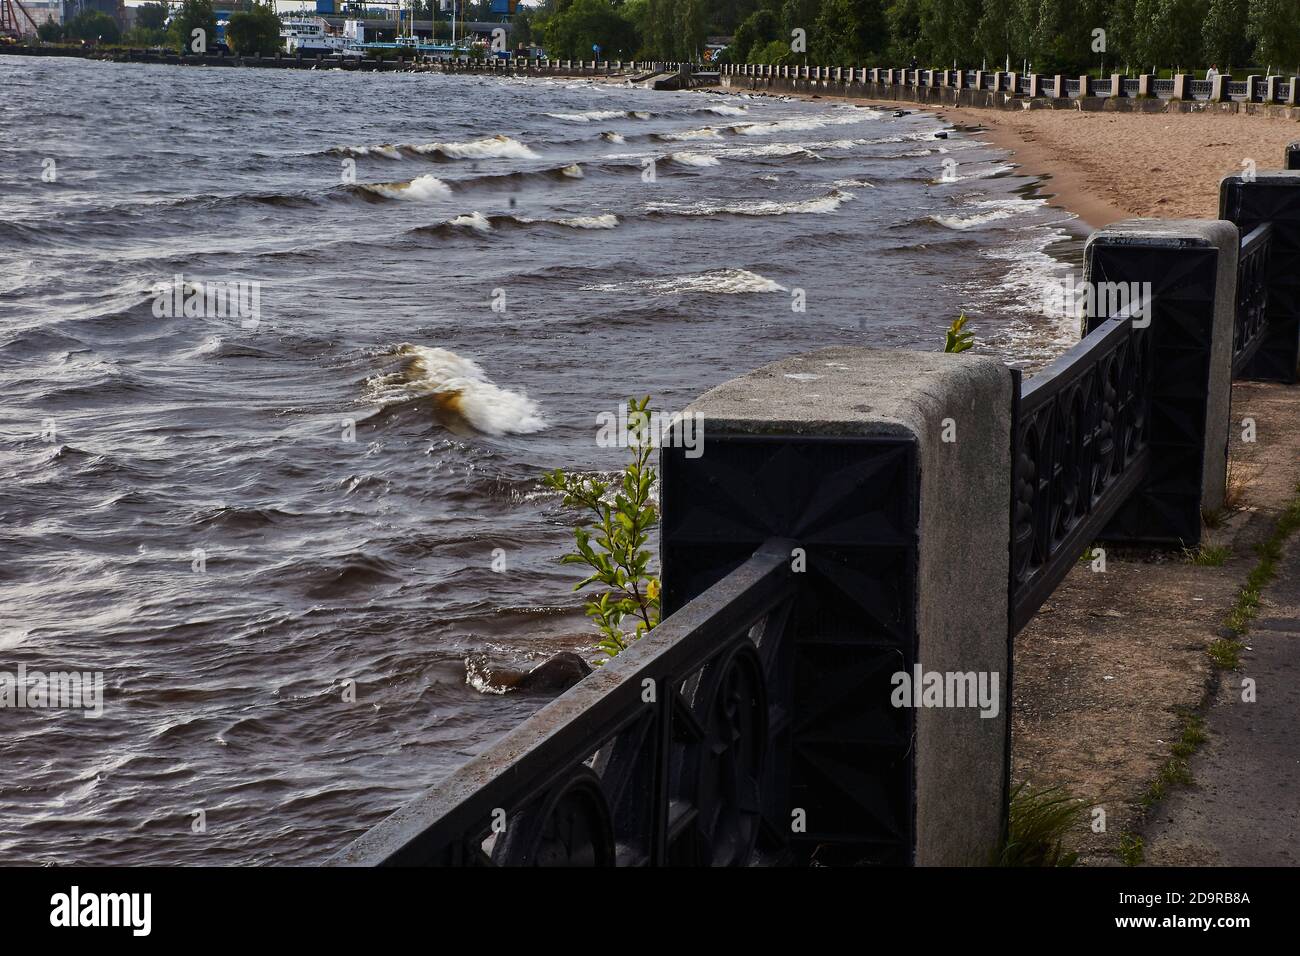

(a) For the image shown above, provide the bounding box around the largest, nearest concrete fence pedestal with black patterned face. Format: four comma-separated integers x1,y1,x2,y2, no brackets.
662,347,1013,865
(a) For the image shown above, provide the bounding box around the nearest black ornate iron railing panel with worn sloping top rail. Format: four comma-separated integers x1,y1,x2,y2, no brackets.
334,541,794,866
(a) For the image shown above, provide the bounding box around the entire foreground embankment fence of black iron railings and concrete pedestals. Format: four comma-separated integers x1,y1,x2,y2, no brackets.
333,150,1300,865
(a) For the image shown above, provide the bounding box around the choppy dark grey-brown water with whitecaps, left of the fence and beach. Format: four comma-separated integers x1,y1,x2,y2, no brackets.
0,57,1078,864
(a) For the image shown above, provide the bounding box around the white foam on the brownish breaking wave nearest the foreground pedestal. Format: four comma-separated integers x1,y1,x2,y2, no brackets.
367,343,546,434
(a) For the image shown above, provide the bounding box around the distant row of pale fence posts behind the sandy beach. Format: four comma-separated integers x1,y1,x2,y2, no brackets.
715,64,1300,109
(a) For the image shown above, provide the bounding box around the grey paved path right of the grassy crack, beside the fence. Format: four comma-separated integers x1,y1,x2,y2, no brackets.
1144,535,1300,866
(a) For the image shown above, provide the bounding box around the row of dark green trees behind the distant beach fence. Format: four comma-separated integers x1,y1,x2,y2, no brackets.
525,0,1300,74
